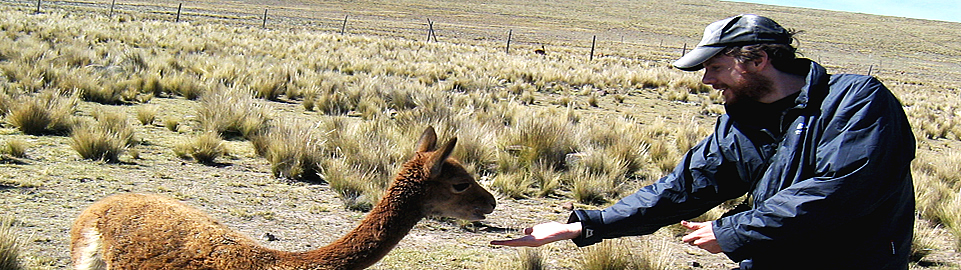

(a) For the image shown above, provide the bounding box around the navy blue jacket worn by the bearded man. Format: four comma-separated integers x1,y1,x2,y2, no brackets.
569,62,915,269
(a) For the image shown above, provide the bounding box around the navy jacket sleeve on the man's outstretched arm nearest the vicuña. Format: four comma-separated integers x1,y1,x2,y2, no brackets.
568,117,763,246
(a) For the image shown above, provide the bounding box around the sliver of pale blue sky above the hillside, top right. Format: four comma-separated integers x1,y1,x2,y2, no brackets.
737,0,961,22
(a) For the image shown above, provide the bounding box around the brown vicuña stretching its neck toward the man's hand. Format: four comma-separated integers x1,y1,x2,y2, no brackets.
70,127,496,269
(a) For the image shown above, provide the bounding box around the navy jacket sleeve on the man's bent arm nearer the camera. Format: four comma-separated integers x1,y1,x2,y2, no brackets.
713,78,915,261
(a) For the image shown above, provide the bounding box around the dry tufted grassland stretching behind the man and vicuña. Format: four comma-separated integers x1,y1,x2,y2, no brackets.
0,0,961,269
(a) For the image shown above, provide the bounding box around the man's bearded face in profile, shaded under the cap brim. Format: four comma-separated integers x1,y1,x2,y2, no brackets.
701,54,773,105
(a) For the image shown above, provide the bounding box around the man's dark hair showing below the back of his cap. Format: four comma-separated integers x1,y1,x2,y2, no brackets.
721,29,808,74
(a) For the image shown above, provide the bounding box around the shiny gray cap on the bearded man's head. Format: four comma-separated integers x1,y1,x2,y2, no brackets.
674,14,791,71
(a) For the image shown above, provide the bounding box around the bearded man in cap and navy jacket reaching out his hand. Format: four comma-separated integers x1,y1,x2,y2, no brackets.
491,15,915,270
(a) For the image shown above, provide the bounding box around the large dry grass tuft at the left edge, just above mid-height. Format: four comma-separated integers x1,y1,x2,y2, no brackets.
6,91,79,135
